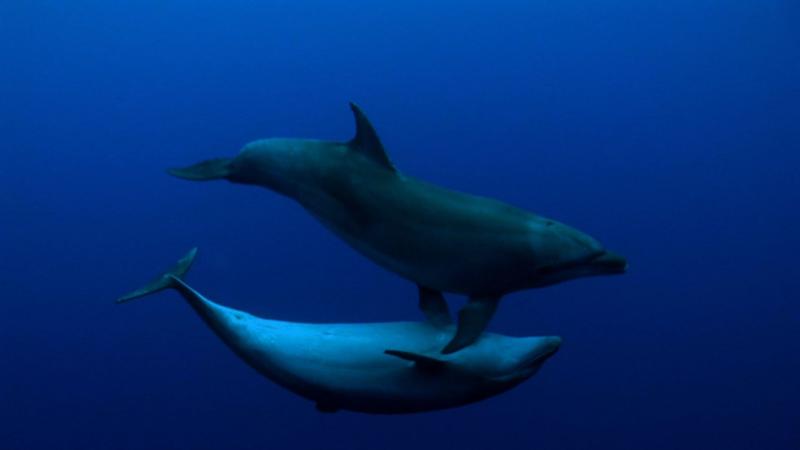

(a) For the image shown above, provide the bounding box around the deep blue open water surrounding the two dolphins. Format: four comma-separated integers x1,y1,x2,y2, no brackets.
0,0,800,450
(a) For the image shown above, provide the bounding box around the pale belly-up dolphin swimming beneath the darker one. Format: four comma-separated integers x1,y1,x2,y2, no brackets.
117,249,561,414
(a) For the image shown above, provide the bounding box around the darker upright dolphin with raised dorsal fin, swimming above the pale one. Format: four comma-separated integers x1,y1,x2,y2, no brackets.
169,104,627,353
